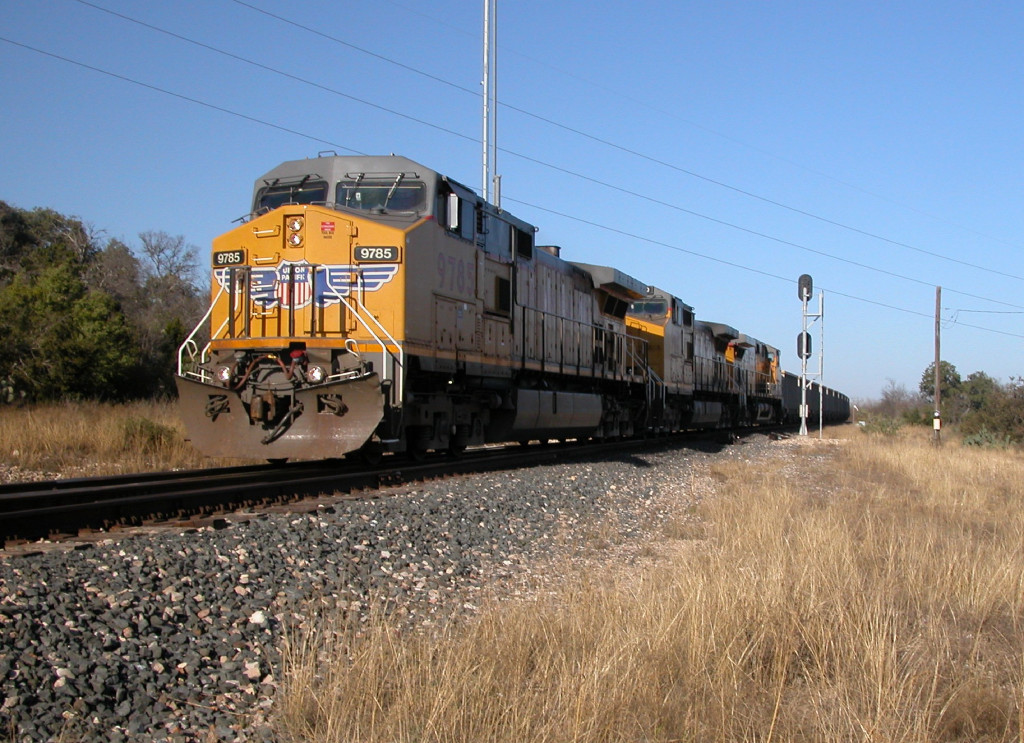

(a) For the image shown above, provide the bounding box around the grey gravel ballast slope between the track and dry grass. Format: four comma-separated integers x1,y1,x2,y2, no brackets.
0,436,798,741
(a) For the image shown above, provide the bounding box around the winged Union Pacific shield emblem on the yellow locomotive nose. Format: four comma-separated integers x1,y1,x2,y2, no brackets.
213,261,398,310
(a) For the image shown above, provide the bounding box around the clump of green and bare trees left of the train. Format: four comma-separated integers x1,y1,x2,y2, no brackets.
0,202,206,401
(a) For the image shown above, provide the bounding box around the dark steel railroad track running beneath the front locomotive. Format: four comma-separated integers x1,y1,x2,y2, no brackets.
0,439,668,545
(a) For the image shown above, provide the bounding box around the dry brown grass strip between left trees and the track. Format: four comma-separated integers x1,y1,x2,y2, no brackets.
0,402,238,479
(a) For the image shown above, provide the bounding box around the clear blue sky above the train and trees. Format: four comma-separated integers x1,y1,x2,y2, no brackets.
0,0,1024,399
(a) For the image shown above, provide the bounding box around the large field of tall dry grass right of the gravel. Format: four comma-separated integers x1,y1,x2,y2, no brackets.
279,435,1024,742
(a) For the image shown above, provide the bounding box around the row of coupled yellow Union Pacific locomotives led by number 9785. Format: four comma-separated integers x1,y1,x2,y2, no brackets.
176,155,849,461
